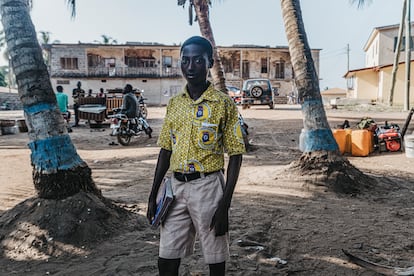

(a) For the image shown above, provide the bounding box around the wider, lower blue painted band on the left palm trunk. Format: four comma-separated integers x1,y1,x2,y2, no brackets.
29,134,84,173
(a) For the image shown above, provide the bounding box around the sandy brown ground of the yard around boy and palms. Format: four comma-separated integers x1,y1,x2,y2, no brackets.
0,105,414,276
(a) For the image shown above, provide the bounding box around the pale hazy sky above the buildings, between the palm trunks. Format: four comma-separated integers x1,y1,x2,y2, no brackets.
23,0,412,90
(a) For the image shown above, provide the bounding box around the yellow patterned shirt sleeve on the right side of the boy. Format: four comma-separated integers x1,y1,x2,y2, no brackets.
223,98,246,156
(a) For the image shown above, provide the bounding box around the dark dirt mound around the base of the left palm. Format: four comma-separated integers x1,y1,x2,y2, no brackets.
0,192,144,259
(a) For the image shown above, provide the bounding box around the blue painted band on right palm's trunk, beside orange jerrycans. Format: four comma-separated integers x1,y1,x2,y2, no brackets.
301,129,339,152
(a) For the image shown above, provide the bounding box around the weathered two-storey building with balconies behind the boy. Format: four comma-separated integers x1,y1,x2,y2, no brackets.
49,44,319,105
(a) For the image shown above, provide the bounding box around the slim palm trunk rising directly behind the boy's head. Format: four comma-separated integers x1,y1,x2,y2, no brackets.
177,0,227,92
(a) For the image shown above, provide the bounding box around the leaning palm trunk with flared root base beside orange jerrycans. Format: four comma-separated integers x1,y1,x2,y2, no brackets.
280,0,370,193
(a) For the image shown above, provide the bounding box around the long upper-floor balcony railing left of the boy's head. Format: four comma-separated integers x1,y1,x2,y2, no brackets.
51,67,182,78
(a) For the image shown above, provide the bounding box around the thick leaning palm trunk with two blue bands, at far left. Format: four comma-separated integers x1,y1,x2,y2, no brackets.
0,0,100,199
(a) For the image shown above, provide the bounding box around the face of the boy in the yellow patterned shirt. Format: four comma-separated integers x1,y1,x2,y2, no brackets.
181,44,210,85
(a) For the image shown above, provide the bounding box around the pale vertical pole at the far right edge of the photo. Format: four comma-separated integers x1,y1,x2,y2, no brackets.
404,0,412,111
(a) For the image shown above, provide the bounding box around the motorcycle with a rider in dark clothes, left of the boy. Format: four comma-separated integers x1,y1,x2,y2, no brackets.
109,108,152,146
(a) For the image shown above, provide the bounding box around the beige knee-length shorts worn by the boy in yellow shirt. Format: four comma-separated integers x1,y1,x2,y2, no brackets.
159,171,229,264
